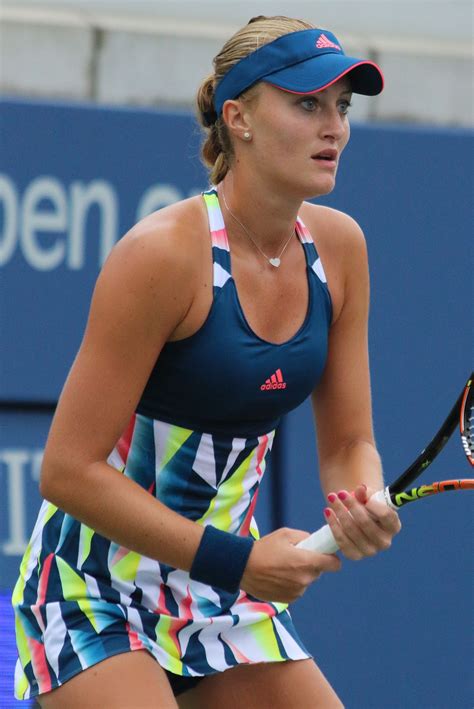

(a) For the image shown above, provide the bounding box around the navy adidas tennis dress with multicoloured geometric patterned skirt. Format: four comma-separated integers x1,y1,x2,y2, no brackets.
13,189,331,699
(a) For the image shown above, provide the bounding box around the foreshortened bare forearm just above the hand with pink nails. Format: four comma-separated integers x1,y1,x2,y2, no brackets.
319,440,383,495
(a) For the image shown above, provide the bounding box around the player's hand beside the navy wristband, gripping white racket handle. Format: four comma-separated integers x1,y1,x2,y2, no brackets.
240,528,341,603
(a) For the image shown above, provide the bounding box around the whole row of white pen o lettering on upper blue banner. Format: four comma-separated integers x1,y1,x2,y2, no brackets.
0,174,201,271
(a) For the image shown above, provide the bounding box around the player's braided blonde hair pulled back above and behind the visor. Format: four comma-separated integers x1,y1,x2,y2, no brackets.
196,15,315,185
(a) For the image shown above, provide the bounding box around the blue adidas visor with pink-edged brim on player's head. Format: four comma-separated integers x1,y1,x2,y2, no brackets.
214,29,383,115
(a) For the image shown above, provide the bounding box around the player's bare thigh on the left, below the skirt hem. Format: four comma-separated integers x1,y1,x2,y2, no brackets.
38,650,177,709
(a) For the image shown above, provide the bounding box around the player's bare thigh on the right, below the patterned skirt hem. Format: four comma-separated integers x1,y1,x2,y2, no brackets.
179,660,343,709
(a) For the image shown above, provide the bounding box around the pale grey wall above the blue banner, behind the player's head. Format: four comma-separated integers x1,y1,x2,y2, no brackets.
0,0,473,126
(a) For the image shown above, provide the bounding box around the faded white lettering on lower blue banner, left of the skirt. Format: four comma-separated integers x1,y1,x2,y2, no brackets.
0,448,43,556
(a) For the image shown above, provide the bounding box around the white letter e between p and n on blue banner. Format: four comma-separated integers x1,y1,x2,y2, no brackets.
21,176,68,271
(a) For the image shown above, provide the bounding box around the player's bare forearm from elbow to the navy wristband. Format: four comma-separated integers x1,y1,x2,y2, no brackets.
41,462,203,571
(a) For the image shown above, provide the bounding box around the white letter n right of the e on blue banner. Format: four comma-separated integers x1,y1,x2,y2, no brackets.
67,180,118,271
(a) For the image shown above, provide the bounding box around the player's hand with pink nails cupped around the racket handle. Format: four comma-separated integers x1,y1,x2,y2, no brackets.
324,485,401,561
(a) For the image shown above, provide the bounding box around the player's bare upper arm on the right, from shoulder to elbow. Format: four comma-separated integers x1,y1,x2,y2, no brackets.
312,207,373,461
